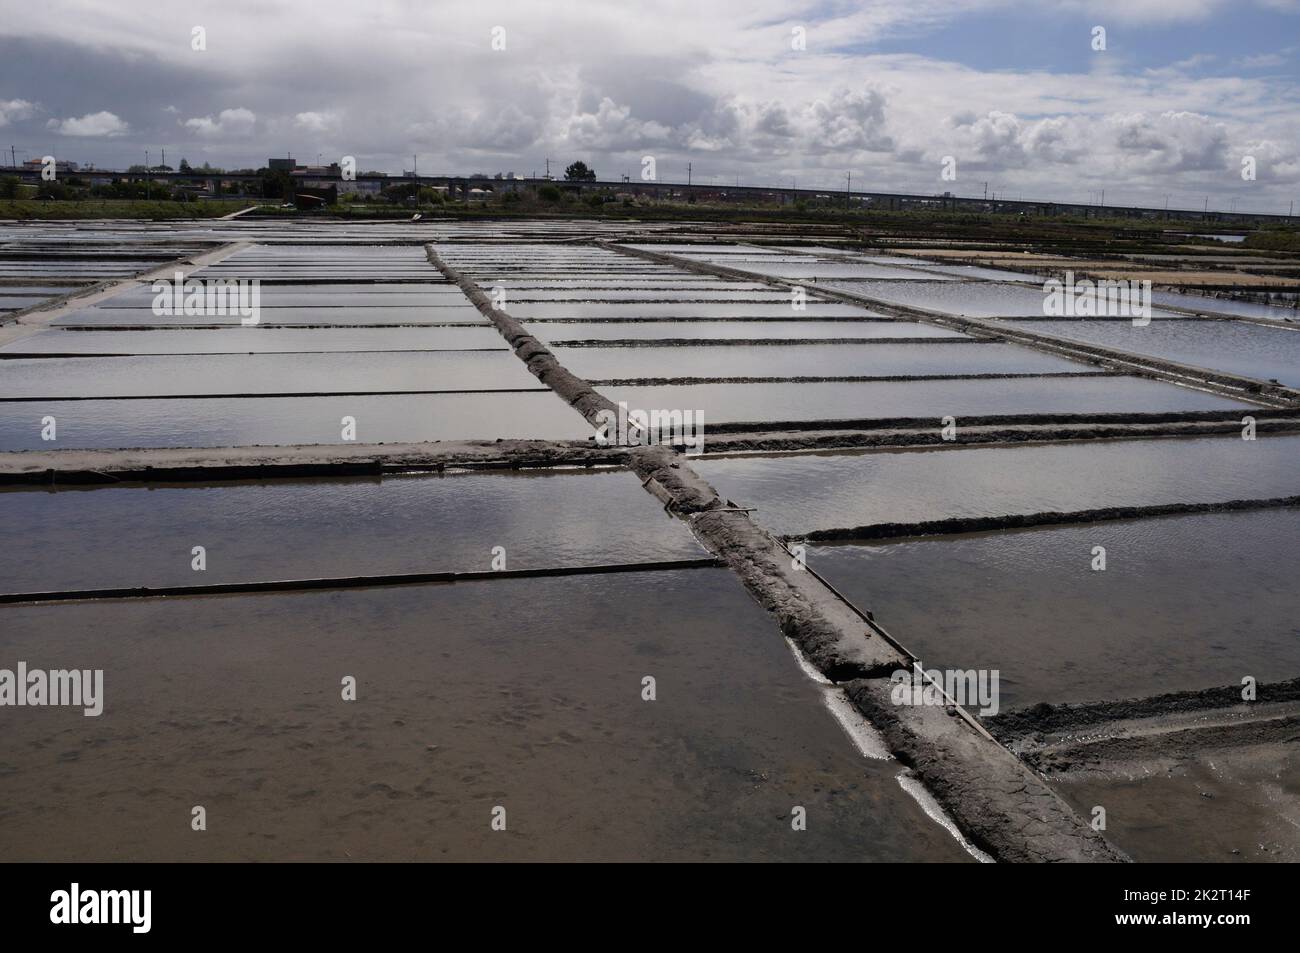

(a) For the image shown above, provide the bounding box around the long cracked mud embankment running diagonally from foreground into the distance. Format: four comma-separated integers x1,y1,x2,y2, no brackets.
439,237,1127,862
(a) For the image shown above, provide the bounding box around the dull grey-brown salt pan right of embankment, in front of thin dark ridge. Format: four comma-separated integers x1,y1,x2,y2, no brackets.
809,508,1300,707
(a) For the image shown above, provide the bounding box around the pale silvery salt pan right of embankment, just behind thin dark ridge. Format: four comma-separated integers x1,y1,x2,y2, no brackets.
692,436,1300,534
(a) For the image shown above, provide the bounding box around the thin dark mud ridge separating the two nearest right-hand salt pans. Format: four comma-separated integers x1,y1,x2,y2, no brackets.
789,497,1300,542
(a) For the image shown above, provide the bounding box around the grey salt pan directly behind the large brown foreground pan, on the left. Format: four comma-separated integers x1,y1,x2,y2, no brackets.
0,471,707,592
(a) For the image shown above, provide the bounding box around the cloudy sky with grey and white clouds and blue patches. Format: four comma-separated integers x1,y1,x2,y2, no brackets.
0,0,1300,212
